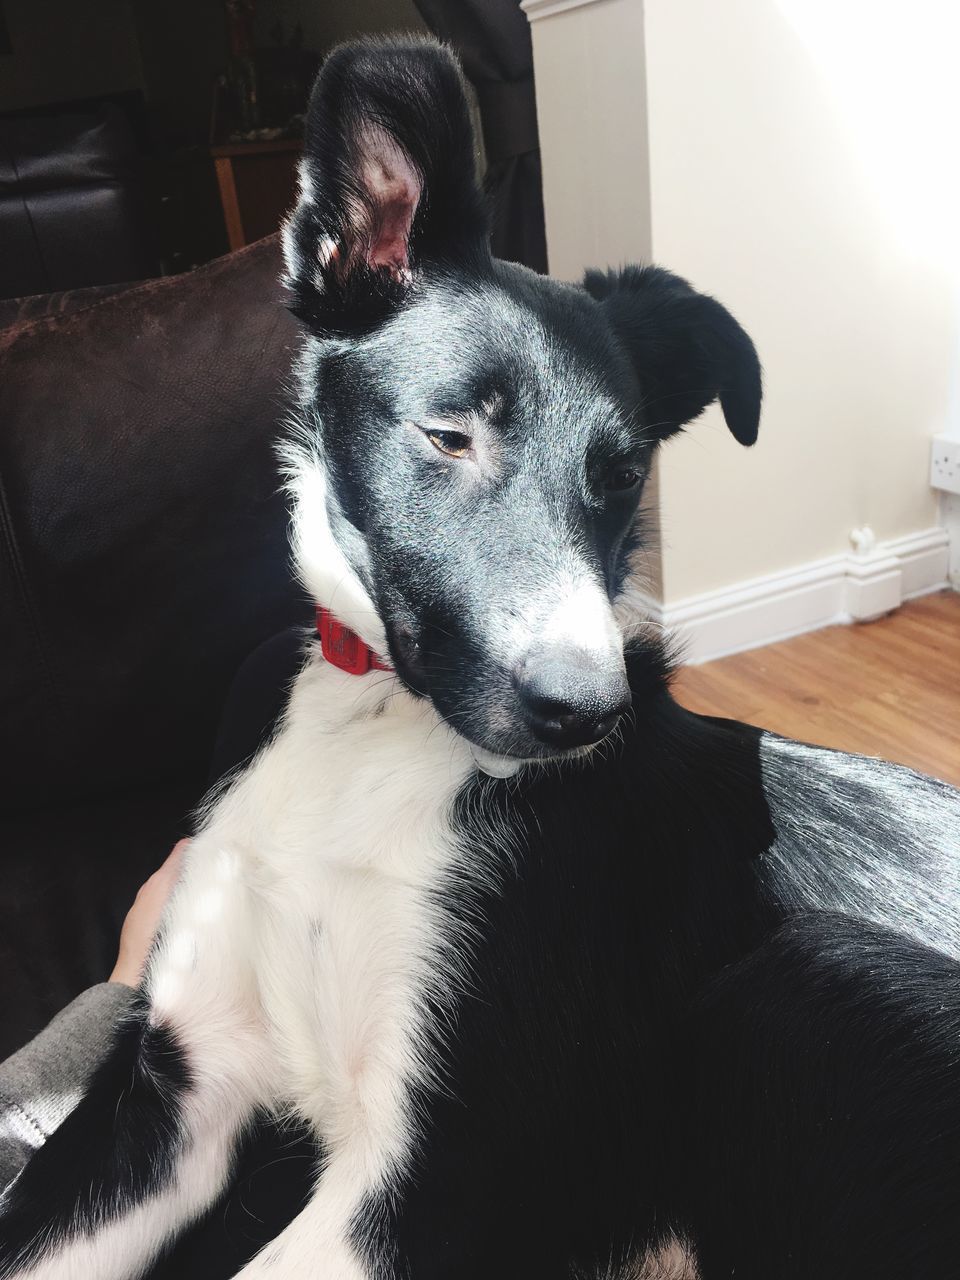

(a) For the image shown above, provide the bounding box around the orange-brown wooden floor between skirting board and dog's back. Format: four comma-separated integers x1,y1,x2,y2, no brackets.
673,591,960,786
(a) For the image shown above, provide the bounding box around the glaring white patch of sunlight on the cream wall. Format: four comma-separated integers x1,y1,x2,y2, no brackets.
778,0,960,279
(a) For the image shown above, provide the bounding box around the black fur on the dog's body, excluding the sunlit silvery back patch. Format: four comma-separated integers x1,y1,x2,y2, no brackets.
366,675,960,1280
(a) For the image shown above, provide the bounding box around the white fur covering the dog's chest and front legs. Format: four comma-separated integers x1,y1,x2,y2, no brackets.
18,586,497,1280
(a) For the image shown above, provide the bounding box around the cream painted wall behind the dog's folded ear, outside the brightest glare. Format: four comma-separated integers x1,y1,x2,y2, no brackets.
531,0,960,603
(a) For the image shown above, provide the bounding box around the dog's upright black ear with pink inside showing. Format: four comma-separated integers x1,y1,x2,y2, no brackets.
283,37,489,333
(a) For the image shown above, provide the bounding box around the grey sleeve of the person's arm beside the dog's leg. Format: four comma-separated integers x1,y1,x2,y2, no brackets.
0,982,137,1190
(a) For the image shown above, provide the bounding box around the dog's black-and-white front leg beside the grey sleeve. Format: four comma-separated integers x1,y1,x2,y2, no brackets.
0,831,273,1280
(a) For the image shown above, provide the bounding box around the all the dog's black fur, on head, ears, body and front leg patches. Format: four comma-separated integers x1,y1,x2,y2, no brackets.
0,42,960,1280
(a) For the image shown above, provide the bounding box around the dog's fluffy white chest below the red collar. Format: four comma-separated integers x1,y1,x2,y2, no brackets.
213,650,474,1160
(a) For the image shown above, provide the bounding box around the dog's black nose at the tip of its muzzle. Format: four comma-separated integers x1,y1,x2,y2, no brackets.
516,649,630,748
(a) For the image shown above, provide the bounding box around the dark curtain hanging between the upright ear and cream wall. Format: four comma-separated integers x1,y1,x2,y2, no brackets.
415,0,547,271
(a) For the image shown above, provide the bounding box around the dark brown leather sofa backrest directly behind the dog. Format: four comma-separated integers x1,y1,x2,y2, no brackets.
0,237,310,1056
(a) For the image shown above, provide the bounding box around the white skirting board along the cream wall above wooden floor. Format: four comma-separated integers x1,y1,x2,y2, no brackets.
645,529,950,664
